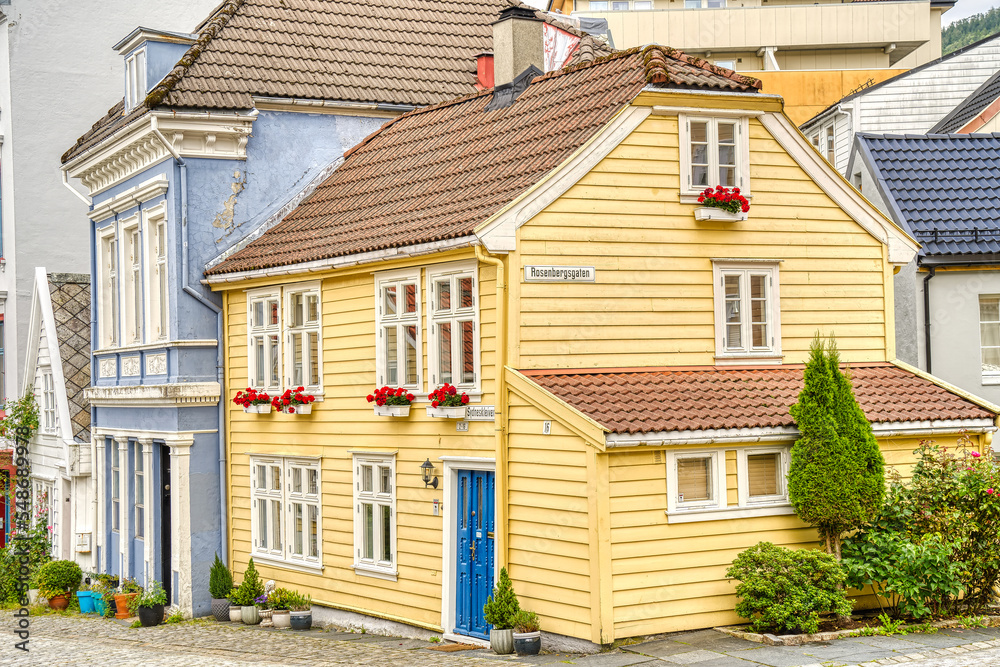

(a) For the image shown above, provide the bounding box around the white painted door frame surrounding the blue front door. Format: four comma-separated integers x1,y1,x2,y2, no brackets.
438,456,500,644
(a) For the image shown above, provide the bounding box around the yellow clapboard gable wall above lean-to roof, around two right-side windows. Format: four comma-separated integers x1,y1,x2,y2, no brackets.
512,116,892,369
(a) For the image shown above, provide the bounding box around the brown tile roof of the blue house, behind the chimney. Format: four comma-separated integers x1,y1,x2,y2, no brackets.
63,0,610,162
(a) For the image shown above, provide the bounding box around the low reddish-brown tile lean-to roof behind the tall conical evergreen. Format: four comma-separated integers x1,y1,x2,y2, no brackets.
522,364,995,434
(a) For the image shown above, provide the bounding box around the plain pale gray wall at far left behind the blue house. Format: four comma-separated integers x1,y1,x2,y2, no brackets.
2,0,219,394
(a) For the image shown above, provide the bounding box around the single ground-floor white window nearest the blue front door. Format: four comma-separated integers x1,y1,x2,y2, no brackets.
354,453,396,576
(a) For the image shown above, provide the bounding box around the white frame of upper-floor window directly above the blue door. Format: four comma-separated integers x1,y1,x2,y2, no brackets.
427,260,483,399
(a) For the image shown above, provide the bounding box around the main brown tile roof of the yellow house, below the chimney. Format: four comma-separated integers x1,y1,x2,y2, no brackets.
206,46,760,275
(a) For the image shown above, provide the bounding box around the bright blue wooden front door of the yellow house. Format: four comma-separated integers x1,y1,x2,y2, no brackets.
455,470,495,639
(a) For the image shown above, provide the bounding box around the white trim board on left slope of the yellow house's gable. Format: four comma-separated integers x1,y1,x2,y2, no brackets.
475,106,652,253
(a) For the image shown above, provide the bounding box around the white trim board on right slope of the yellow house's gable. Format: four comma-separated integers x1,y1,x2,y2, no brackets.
760,113,920,266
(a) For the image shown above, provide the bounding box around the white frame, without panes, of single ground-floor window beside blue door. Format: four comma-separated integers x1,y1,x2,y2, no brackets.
352,452,399,581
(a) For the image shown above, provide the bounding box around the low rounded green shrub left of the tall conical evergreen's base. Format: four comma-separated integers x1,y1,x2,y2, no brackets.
726,542,851,633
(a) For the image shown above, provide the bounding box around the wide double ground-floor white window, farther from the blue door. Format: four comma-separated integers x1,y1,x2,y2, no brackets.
250,456,323,567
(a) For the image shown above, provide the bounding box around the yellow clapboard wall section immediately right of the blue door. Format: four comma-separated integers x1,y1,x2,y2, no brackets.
507,392,600,643
